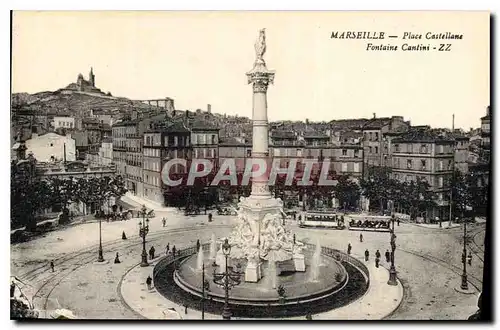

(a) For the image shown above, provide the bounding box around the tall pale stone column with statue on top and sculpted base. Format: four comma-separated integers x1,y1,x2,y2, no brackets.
229,29,305,282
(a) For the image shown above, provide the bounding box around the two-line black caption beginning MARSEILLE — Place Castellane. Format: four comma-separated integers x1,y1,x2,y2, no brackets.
330,31,463,51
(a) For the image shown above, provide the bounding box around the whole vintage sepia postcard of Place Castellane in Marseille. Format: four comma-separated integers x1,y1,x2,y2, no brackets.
9,11,493,321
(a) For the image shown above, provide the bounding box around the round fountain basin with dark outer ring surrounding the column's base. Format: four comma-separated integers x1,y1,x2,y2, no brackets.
153,244,369,318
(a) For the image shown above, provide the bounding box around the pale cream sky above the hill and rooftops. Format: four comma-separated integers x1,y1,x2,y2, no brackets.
12,11,490,130
